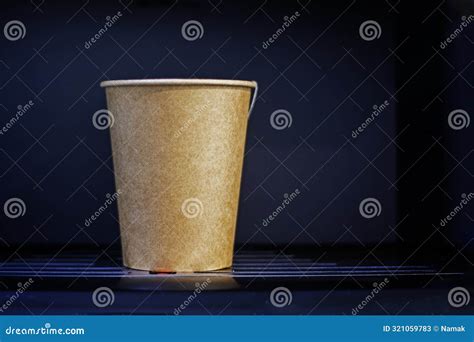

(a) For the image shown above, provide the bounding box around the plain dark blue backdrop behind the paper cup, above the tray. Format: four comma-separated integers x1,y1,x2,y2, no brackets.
0,0,474,258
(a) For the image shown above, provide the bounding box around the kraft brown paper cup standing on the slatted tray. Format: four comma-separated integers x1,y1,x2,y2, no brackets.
101,79,257,272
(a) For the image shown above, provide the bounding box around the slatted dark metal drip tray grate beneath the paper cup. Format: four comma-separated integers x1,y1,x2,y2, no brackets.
0,251,459,290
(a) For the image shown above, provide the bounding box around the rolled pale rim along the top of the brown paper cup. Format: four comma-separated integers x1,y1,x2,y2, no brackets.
100,78,257,88
